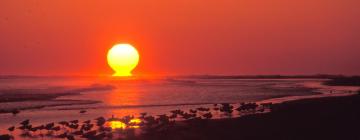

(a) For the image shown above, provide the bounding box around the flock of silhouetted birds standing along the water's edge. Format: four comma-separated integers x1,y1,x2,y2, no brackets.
0,103,272,140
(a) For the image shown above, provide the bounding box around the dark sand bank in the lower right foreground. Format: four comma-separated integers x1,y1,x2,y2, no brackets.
138,95,360,140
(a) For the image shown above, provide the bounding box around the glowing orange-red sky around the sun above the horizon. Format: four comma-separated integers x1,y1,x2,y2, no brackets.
0,0,360,75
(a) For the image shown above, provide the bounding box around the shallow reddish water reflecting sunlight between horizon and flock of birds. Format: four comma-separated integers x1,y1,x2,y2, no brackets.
0,77,357,136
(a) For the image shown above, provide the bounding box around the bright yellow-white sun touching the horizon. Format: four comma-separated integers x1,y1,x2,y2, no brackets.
107,44,139,76
